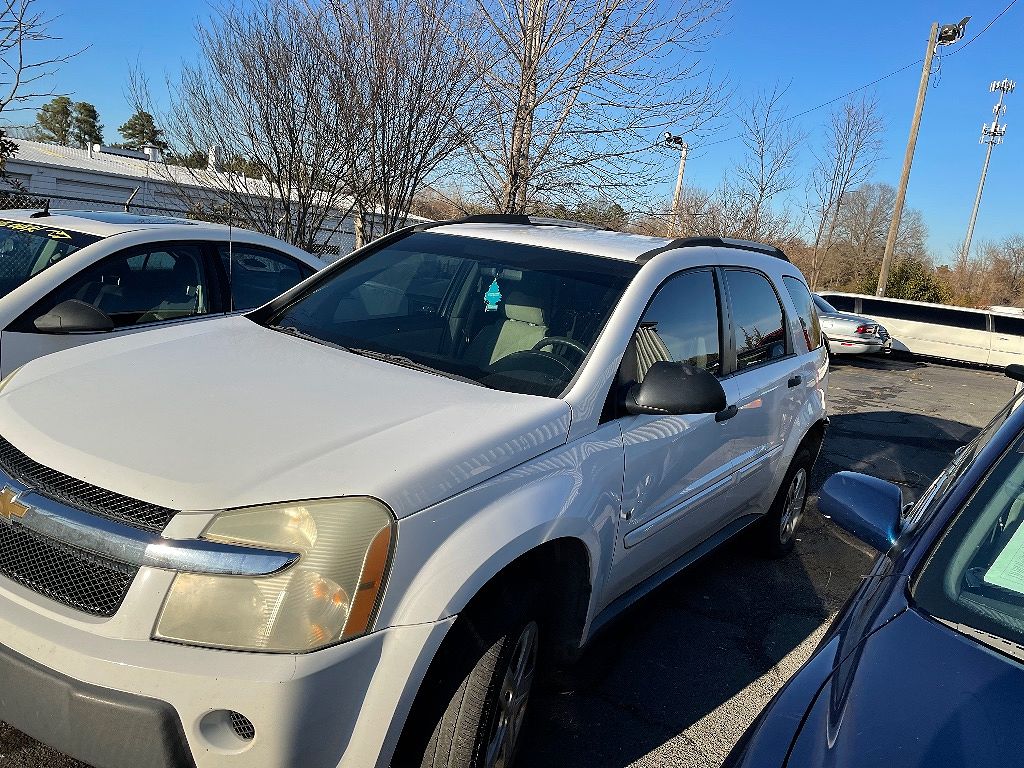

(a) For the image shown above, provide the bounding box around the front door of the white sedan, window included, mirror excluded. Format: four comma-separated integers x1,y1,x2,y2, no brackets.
0,243,220,374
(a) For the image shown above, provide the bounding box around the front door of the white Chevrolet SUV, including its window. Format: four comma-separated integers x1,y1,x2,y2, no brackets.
606,269,735,600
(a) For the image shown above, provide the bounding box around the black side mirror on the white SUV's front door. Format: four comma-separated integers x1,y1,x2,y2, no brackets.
626,360,726,416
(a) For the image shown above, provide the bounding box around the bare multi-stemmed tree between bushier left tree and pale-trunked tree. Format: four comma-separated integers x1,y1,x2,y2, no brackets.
318,0,480,240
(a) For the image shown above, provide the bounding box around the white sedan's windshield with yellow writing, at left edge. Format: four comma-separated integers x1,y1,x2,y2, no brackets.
0,218,101,296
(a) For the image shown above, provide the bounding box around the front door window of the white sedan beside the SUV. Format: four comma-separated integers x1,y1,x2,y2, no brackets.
32,244,210,328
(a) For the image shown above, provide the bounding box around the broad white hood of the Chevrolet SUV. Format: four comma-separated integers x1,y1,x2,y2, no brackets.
0,317,570,517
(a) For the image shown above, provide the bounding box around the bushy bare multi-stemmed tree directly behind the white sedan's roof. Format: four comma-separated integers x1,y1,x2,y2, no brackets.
159,0,353,251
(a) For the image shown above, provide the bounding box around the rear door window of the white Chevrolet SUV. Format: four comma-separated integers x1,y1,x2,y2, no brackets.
725,269,785,371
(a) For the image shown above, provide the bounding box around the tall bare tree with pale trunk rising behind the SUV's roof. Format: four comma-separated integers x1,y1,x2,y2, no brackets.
469,0,725,213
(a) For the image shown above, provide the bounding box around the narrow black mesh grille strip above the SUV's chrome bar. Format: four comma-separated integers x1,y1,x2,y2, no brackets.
0,437,175,534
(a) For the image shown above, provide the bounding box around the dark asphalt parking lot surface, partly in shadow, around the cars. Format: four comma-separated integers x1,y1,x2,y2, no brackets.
0,358,1014,768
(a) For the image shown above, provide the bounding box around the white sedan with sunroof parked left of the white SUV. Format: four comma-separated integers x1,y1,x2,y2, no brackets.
0,210,324,376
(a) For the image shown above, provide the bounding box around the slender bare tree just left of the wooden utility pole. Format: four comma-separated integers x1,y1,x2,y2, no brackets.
807,97,883,287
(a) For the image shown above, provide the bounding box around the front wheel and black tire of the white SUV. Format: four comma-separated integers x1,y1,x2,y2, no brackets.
391,603,540,768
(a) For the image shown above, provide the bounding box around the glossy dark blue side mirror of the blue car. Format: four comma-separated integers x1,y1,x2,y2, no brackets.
818,472,903,552
